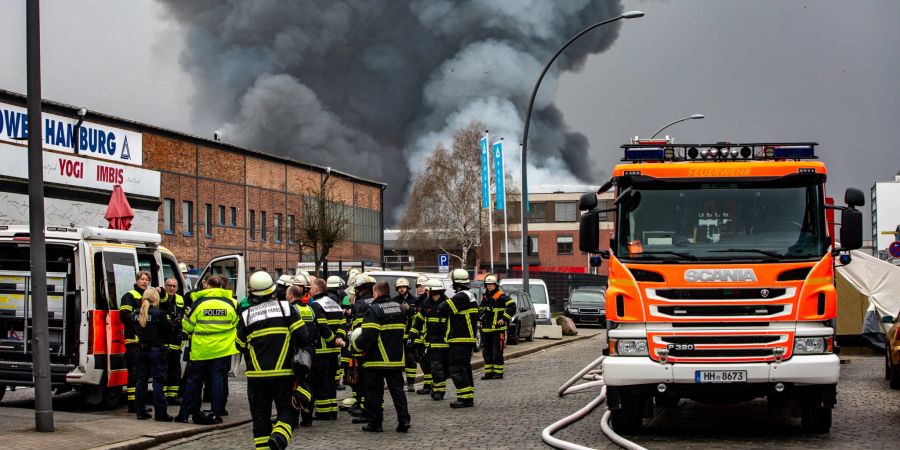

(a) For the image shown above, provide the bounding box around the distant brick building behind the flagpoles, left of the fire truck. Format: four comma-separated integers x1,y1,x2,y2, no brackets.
479,186,613,275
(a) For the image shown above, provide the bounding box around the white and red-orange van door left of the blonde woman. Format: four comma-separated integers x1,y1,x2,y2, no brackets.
91,244,138,386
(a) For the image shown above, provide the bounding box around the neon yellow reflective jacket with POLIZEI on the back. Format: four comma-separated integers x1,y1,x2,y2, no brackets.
181,288,238,361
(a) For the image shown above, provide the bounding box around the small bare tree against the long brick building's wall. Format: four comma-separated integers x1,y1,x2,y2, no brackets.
294,174,351,274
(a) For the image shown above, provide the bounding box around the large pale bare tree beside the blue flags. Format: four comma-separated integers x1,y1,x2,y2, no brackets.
400,121,484,268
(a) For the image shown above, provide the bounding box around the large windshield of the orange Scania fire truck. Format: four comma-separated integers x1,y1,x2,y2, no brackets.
616,182,826,262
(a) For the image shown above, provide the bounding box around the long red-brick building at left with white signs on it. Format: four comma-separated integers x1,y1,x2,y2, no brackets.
0,90,386,273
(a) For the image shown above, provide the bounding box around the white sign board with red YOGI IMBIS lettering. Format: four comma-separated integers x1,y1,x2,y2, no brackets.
0,143,160,198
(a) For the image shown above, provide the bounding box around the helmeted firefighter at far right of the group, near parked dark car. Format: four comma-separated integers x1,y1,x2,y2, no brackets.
478,275,516,380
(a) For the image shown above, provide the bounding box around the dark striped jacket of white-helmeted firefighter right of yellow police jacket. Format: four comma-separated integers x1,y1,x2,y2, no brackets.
235,297,309,378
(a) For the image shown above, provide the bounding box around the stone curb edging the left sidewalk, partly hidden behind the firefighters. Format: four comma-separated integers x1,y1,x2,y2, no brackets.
100,328,599,450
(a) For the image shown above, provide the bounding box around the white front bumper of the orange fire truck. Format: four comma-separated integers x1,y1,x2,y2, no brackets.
603,354,840,386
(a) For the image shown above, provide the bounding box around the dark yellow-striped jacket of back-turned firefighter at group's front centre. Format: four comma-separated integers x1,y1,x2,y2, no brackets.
352,295,406,370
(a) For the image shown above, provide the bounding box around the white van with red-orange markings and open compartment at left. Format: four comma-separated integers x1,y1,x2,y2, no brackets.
0,225,186,406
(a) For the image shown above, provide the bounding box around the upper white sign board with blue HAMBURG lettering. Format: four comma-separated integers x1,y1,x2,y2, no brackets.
0,103,144,166
